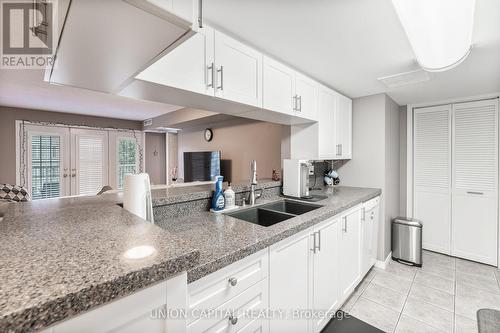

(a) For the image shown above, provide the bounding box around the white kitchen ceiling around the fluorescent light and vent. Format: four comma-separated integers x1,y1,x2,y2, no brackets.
204,0,500,105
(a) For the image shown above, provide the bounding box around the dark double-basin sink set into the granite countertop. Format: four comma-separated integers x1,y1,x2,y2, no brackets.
226,199,323,227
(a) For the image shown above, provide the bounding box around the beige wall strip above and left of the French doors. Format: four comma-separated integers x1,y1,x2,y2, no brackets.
0,106,142,184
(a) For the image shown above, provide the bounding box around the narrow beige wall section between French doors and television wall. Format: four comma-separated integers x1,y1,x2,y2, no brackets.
144,133,166,184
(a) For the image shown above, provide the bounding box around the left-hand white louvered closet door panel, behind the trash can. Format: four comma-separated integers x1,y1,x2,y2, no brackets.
413,105,451,254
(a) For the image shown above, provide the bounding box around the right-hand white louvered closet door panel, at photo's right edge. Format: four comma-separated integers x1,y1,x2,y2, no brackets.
452,99,498,265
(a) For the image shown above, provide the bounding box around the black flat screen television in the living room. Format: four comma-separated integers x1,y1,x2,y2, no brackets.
184,151,221,183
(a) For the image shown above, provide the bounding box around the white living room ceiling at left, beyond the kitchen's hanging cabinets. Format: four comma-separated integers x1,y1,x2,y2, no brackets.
0,69,181,120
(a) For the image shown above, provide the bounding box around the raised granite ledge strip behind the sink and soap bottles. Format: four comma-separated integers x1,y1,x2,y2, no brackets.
151,179,281,207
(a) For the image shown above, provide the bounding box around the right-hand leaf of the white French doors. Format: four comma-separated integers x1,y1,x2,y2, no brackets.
71,128,108,195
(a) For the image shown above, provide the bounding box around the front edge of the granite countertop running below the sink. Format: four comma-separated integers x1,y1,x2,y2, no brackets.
188,189,382,283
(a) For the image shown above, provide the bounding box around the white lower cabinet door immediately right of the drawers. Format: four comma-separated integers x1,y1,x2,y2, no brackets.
269,229,314,333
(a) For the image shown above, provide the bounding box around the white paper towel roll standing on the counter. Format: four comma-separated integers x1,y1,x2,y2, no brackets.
123,173,154,223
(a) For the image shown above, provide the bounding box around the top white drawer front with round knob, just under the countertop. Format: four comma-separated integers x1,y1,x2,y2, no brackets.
188,249,269,322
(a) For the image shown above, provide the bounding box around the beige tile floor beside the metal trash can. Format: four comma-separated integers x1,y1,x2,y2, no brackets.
342,251,500,333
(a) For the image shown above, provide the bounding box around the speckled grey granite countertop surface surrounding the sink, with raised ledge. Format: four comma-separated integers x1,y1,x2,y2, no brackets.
0,181,381,332
